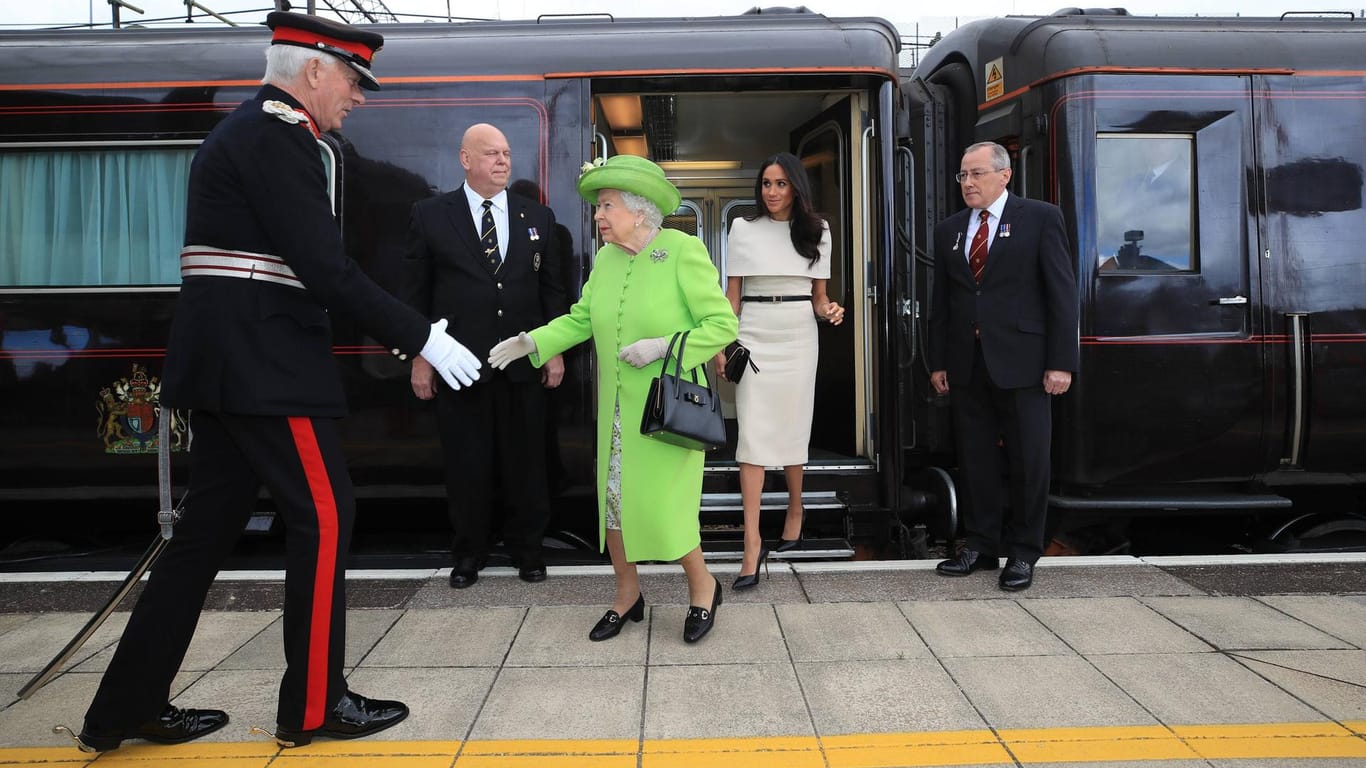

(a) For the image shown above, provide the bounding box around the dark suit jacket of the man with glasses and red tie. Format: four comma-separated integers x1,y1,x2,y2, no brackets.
930,195,1078,389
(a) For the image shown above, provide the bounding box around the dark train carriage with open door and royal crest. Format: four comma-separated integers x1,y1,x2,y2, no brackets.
0,12,902,555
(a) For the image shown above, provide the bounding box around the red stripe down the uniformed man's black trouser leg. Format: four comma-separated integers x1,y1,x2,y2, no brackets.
290,415,337,731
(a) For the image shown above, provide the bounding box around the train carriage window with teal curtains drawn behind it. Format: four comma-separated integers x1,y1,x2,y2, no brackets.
0,146,194,287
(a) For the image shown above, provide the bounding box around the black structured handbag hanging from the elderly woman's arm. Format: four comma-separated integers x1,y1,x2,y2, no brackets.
641,331,725,451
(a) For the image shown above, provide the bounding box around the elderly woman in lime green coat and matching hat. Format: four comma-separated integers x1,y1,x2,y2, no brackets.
489,154,739,642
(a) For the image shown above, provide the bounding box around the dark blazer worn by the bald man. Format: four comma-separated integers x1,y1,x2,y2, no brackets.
400,186,568,383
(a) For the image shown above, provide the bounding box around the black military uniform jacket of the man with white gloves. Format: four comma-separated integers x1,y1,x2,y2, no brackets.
163,85,430,417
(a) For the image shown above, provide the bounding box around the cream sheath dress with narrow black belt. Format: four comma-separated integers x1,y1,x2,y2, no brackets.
725,216,831,466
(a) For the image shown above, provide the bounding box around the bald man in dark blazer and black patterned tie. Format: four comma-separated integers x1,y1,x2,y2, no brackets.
403,123,568,589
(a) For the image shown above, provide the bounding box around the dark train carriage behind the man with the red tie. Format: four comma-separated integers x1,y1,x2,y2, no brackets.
904,10,1366,543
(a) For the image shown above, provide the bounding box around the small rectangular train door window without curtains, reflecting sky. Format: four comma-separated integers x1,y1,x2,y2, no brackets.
1096,134,1198,275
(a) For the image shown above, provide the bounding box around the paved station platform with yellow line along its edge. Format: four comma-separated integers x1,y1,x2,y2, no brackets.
0,555,1366,768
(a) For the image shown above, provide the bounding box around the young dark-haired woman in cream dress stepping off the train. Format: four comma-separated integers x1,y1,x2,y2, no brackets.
717,152,844,589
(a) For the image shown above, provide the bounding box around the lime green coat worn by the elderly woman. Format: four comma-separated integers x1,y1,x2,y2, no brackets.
530,230,739,562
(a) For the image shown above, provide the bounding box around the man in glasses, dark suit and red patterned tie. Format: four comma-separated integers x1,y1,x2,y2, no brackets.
930,142,1078,590
